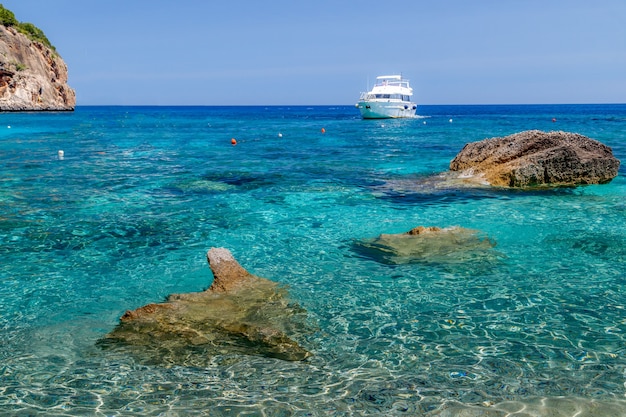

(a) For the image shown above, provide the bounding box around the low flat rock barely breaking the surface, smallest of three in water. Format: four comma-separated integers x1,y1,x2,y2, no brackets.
354,226,496,264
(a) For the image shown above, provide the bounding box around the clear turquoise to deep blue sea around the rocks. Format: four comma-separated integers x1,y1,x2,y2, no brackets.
0,104,626,417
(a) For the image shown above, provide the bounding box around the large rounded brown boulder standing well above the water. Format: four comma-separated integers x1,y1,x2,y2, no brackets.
450,130,620,187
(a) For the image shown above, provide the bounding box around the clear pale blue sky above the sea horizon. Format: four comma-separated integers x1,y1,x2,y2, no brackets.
0,0,626,105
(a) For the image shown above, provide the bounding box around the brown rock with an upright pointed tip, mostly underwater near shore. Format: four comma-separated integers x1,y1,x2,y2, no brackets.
99,248,310,364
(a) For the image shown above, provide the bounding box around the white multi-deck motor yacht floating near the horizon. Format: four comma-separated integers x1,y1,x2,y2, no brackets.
356,75,417,119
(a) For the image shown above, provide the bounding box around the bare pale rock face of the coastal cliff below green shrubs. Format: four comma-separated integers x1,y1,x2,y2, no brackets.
0,24,76,111
